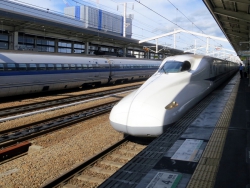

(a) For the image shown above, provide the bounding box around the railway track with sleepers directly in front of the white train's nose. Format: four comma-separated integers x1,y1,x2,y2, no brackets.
42,136,146,188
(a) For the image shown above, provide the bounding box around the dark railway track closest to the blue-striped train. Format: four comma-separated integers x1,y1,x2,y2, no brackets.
0,84,141,118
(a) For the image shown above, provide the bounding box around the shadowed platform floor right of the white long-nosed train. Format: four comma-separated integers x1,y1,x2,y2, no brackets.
99,74,250,188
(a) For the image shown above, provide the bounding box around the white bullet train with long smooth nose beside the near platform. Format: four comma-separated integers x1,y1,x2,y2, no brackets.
109,54,238,137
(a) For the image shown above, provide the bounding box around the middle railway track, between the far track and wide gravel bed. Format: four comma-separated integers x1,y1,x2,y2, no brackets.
0,100,119,161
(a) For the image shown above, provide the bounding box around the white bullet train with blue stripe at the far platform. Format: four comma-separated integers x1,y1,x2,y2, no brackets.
0,52,161,97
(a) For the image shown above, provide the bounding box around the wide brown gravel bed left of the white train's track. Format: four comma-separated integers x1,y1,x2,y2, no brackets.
0,114,123,188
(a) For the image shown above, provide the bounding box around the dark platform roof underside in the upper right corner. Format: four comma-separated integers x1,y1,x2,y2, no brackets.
203,0,250,53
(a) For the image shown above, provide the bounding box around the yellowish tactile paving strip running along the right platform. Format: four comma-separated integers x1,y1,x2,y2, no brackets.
187,79,239,188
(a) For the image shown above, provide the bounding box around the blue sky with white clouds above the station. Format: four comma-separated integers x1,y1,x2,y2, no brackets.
8,0,236,53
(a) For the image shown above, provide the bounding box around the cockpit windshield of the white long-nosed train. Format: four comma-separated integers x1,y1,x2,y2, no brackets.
159,60,191,73
